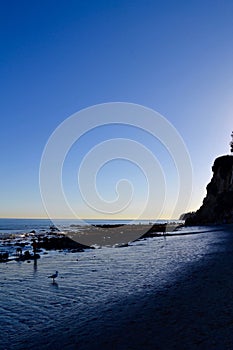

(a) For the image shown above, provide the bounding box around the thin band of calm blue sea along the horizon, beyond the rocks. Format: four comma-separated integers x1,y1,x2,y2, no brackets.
0,219,178,234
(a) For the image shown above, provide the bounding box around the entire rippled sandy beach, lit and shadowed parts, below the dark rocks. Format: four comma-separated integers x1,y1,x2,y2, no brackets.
0,225,233,349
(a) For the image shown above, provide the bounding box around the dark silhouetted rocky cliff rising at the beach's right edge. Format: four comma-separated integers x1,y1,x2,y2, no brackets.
185,155,233,225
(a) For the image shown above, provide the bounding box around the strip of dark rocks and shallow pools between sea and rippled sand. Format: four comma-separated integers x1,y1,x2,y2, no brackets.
0,223,228,263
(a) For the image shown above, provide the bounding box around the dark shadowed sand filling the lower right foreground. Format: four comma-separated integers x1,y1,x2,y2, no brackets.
19,228,233,350
